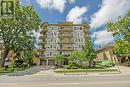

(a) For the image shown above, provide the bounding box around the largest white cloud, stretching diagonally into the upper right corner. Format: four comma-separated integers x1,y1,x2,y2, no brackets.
90,0,130,28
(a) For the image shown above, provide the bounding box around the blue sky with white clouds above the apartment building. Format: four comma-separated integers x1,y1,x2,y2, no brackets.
20,0,130,48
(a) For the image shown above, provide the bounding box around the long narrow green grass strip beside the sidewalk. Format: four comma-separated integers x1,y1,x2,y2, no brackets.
54,69,117,73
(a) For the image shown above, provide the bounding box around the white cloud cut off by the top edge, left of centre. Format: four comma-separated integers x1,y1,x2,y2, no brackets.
37,0,75,13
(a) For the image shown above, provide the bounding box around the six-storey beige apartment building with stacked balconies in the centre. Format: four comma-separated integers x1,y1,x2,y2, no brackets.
40,22,89,65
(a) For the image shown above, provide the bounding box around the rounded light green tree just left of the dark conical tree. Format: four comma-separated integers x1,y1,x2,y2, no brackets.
69,51,85,66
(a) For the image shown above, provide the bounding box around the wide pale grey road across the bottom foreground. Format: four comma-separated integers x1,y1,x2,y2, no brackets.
0,75,130,87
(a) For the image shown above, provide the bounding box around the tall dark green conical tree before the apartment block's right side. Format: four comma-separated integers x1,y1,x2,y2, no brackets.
82,40,96,67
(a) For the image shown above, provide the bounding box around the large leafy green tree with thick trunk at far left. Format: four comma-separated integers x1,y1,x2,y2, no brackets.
0,0,40,66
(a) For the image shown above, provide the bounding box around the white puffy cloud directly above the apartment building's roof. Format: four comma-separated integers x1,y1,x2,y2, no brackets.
66,6,87,23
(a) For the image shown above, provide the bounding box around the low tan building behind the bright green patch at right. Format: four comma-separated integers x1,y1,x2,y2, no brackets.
96,46,118,64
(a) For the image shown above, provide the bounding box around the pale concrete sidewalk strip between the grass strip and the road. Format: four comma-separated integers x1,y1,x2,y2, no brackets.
27,66,130,77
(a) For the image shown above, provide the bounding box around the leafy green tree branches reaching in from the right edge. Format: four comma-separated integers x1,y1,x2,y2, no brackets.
106,11,130,61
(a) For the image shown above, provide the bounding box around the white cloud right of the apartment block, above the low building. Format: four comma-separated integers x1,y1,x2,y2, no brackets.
92,30,114,46
